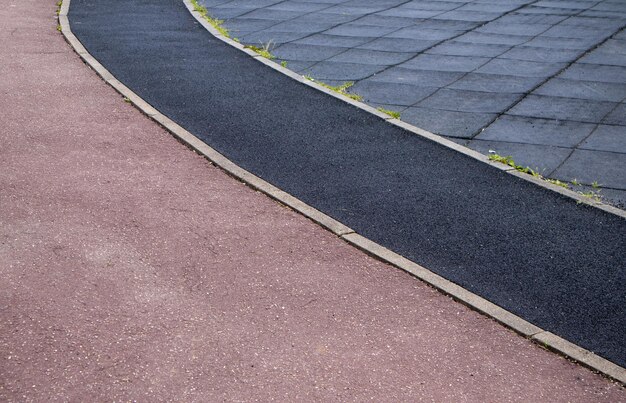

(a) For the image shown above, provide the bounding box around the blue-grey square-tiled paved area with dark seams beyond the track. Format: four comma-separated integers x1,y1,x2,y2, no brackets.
199,0,626,208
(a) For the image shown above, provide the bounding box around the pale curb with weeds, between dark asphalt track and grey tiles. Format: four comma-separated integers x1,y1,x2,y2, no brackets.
182,0,626,218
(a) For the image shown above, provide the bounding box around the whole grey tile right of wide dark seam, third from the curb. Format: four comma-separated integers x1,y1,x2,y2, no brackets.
508,95,616,123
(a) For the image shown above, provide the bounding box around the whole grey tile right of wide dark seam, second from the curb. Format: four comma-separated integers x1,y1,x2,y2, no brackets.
476,115,596,147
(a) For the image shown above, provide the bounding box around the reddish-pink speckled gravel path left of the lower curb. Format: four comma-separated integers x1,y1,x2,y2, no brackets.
0,0,626,402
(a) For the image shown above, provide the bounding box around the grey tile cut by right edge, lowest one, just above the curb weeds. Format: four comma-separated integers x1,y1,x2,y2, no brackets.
552,150,626,189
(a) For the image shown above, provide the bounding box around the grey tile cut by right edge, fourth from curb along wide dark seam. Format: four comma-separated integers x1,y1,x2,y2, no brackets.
533,78,626,102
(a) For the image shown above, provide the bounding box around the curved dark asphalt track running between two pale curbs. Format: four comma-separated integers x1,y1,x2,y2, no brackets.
70,0,626,366
